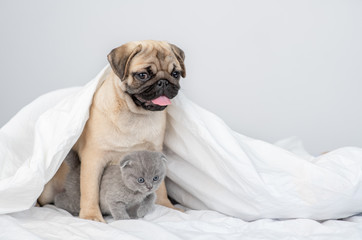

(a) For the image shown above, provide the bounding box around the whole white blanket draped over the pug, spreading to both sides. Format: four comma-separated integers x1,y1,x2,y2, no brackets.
0,66,362,220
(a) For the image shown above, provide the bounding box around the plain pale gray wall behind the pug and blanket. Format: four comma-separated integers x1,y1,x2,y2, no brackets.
0,0,362,154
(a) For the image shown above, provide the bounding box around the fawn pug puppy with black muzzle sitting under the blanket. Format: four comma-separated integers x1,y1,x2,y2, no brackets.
39,41,186,222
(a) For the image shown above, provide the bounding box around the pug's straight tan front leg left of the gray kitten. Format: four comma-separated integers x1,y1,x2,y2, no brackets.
79,151,105,223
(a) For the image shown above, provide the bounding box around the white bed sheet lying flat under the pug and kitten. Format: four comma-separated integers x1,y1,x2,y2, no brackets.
0,205,362,240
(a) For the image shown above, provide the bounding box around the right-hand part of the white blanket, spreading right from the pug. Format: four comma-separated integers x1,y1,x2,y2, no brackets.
165,94,362,220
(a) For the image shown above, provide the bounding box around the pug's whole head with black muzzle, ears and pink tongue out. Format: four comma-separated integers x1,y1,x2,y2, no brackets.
108,41,186,111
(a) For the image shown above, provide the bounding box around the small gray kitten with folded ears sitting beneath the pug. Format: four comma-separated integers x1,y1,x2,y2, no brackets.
54,151,166,220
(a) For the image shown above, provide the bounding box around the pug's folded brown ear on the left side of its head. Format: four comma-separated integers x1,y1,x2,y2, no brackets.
107,43,142,81
